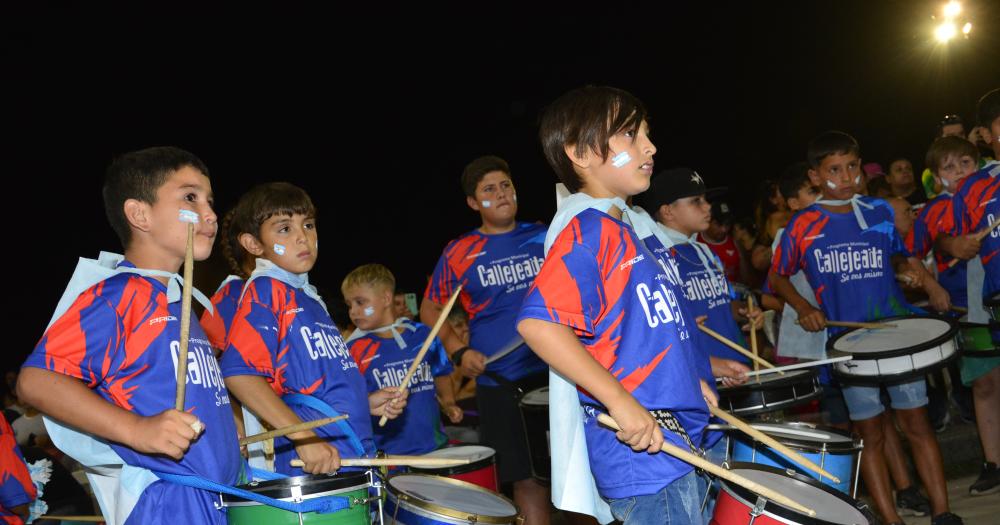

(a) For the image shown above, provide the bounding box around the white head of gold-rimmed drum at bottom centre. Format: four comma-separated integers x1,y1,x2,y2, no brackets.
388,474,517,523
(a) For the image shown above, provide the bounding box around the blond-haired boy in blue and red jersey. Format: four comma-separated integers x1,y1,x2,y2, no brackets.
340,264,462,455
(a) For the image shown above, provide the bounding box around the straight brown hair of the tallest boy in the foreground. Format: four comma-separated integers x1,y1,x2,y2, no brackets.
538,86,648,193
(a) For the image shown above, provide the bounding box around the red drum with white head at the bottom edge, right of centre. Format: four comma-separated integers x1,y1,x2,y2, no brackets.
710,463,878,525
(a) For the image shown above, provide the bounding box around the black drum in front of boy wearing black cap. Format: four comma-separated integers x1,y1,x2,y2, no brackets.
719,370,823,416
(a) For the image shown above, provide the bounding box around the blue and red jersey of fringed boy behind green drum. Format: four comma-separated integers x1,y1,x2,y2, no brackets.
220,276,374,475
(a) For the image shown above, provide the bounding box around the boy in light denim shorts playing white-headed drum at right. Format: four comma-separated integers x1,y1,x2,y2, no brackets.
770,131,961,525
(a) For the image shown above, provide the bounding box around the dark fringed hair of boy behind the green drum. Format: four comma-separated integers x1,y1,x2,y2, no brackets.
226,182,316,243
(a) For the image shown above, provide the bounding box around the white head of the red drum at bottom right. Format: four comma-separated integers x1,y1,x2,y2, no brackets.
722,463,874,525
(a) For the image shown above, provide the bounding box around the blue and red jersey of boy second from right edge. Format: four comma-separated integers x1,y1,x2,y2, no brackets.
906,193,969,307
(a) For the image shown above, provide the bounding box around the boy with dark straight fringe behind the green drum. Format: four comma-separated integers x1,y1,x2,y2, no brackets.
221,182,406,475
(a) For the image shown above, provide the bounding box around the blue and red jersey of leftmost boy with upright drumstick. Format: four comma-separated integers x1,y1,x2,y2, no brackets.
24,262,244,523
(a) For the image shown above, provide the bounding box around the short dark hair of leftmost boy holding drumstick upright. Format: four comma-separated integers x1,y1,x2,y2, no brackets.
101,146,208,249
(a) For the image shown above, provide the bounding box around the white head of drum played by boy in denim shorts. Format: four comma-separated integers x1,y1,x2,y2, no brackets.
826,315,958,359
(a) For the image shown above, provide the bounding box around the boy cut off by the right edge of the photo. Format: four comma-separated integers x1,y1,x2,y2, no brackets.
936,89,1000,495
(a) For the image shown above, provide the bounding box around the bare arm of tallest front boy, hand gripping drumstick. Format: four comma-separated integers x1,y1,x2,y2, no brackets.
517,319,663,452
